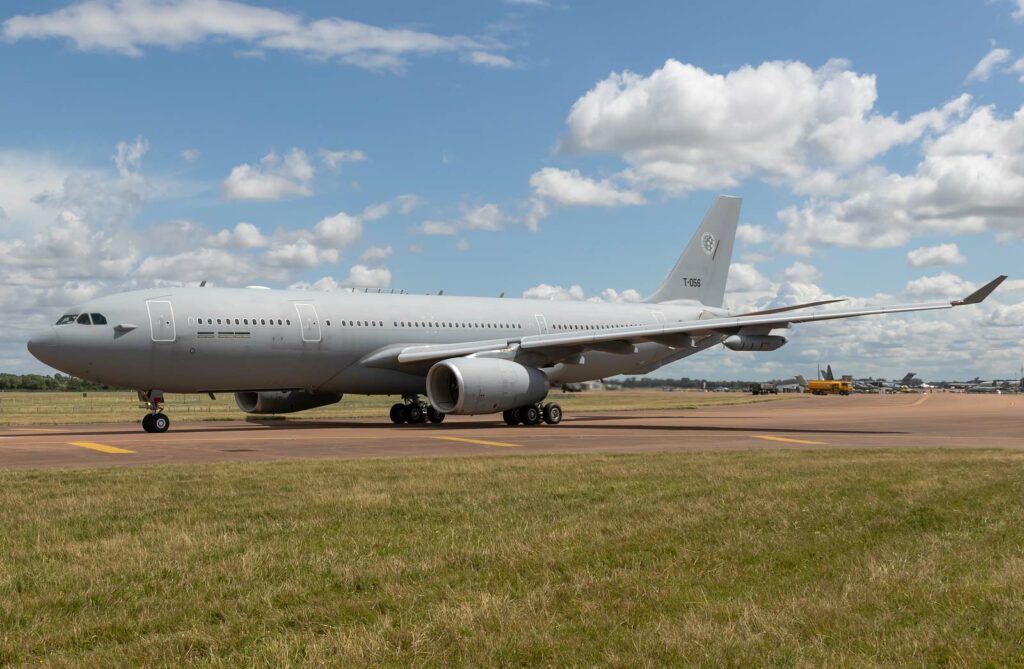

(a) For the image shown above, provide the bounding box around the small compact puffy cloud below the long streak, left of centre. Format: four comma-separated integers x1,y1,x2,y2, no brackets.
224,149,315,200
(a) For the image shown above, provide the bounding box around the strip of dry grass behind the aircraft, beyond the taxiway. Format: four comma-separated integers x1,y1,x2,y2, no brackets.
0,390,788,425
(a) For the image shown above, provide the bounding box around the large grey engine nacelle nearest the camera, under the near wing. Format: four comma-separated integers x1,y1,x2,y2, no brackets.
427,358,550,415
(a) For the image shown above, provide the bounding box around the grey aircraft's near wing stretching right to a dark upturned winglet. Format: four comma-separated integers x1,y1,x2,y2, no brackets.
391,276,1007,364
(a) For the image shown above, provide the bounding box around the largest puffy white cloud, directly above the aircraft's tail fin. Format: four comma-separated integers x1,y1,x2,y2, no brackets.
561,59,970,193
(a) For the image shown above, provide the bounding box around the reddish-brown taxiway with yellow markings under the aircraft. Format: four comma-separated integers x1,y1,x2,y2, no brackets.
0,393,1024,468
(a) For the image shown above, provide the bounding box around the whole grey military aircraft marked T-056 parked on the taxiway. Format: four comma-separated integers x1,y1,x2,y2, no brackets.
29,196,1006,432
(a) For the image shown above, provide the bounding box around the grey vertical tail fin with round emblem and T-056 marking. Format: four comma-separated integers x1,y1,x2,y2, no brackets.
644,195,742,306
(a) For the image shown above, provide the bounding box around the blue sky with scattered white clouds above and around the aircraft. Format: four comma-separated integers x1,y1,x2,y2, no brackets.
0,0,1024,379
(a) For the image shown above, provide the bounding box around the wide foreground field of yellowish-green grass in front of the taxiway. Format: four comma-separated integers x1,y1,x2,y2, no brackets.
0,451,1024,667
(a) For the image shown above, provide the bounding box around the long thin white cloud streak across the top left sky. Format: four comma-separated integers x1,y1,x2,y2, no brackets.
3,0,503,71
